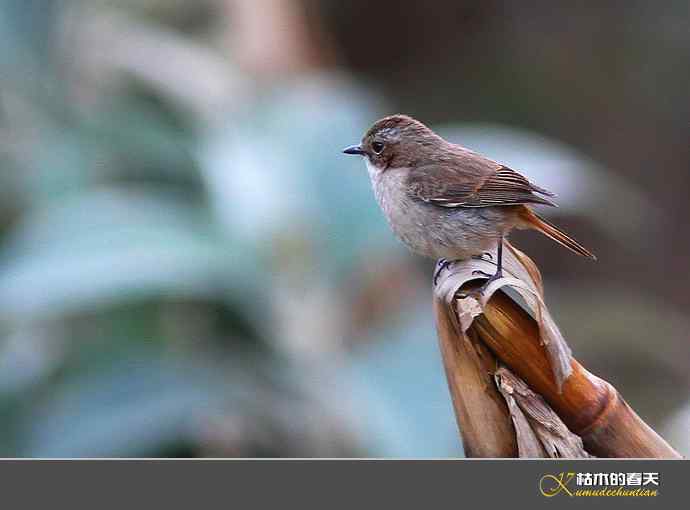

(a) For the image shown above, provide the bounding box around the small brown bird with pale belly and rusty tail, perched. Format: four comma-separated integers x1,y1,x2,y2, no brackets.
343,115,596,285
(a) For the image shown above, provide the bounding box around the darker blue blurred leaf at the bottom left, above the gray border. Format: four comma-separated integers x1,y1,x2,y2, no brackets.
22,351,223,457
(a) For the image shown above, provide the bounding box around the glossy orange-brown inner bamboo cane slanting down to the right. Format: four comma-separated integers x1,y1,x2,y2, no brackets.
470,291,682,459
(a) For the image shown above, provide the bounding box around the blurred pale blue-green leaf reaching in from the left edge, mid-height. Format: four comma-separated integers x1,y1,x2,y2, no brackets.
0,190,257,320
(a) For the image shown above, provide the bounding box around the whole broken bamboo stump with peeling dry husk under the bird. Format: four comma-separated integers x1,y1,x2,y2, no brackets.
434,245,681,459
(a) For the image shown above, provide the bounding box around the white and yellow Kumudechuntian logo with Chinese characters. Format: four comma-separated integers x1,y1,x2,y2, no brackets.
539,472,659,498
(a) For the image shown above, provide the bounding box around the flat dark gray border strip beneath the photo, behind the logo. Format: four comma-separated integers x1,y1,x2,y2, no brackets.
0,459,690,510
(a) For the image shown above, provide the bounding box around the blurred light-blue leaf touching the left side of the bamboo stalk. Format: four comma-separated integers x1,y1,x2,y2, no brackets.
344,304,462,457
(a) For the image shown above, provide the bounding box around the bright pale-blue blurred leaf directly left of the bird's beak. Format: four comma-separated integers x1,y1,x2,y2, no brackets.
200,79,395,276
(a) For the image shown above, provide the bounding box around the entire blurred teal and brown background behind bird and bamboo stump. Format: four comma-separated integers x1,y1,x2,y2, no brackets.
0,0,690,457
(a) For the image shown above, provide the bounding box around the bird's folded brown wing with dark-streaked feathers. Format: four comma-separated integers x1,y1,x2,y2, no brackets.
407,160,556,207
